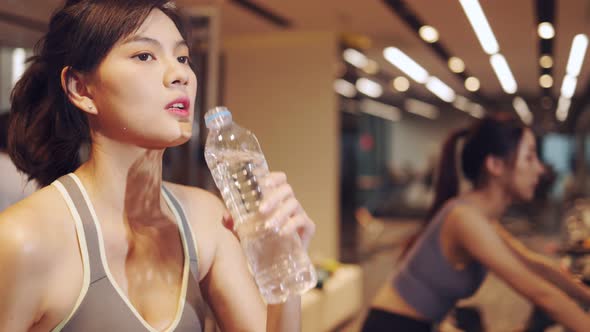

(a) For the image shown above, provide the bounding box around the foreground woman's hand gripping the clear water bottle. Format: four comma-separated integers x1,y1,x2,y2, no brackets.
223,172,315,249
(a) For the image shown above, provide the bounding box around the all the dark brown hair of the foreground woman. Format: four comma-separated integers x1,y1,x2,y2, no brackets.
8,0,189,186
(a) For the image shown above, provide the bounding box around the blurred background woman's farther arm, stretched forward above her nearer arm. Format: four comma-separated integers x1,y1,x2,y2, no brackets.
495,223,590,305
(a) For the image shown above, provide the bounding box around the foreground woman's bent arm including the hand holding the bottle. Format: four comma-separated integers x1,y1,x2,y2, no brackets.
183,173,315,332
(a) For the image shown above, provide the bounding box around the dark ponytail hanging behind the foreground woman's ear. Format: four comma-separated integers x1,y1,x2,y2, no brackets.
8,56,88,186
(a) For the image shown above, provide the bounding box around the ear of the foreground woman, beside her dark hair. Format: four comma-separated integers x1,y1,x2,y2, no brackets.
61,67,98,114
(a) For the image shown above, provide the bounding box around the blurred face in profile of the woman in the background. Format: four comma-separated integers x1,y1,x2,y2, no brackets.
508,129,545,201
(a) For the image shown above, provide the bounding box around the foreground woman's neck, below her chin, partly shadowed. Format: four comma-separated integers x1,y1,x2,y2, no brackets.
76,137,164,220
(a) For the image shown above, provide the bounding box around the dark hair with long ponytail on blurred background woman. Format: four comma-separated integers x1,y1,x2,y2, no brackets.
402,112,526,255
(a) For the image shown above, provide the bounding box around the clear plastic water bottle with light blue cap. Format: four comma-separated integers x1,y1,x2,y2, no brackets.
205,107,317,304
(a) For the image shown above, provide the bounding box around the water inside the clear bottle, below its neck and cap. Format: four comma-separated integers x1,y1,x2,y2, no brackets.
206,151,317,303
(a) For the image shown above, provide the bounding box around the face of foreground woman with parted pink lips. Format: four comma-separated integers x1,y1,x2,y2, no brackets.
88,10,197,149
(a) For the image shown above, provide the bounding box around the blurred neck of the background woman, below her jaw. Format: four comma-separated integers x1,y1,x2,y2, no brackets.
462,186,512,220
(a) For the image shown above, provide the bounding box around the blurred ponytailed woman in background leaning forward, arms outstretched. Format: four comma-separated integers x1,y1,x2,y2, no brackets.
363,113,590,332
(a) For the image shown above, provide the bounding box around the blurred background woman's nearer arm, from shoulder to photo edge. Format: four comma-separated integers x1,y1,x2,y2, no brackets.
449,206,590,332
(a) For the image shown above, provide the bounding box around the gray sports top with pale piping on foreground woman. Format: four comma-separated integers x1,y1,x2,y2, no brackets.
52,173,213,332
